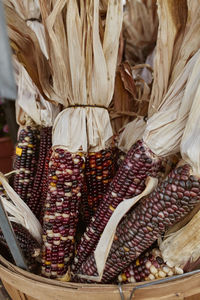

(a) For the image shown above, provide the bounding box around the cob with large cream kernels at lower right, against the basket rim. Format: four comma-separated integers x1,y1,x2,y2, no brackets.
118,248,183,283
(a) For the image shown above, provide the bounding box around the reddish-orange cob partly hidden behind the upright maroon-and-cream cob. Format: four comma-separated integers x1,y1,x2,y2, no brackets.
82,148,115,224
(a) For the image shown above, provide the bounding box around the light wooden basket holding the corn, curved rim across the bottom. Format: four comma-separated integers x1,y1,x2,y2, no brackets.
0,256,200,300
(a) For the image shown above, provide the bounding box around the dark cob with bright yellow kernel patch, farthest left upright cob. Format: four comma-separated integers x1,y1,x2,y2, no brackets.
14,126,40,203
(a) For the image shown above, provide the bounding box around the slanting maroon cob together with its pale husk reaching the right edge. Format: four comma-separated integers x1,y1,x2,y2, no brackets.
73,5,200,273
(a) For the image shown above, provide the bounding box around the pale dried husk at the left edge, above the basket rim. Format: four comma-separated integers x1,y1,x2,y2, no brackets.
0,172,42,243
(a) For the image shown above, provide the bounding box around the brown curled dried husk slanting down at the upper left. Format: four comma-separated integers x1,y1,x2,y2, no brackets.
4,2,58,102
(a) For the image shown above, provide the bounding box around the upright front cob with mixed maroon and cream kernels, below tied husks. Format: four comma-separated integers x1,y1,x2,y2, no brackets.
42,149,85,278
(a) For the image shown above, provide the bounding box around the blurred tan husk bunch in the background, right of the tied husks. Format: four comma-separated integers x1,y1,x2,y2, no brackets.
123,0,158,65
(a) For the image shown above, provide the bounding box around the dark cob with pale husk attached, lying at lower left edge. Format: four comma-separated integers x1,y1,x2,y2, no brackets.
0,173,42,269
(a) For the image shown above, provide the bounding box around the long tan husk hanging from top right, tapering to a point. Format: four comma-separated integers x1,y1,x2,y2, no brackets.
148,0,187,116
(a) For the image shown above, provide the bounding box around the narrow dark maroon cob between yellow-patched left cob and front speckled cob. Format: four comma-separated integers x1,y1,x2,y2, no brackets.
27,127,52,219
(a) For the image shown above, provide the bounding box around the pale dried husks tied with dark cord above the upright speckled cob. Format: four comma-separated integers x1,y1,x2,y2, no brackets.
45,0,122,152
